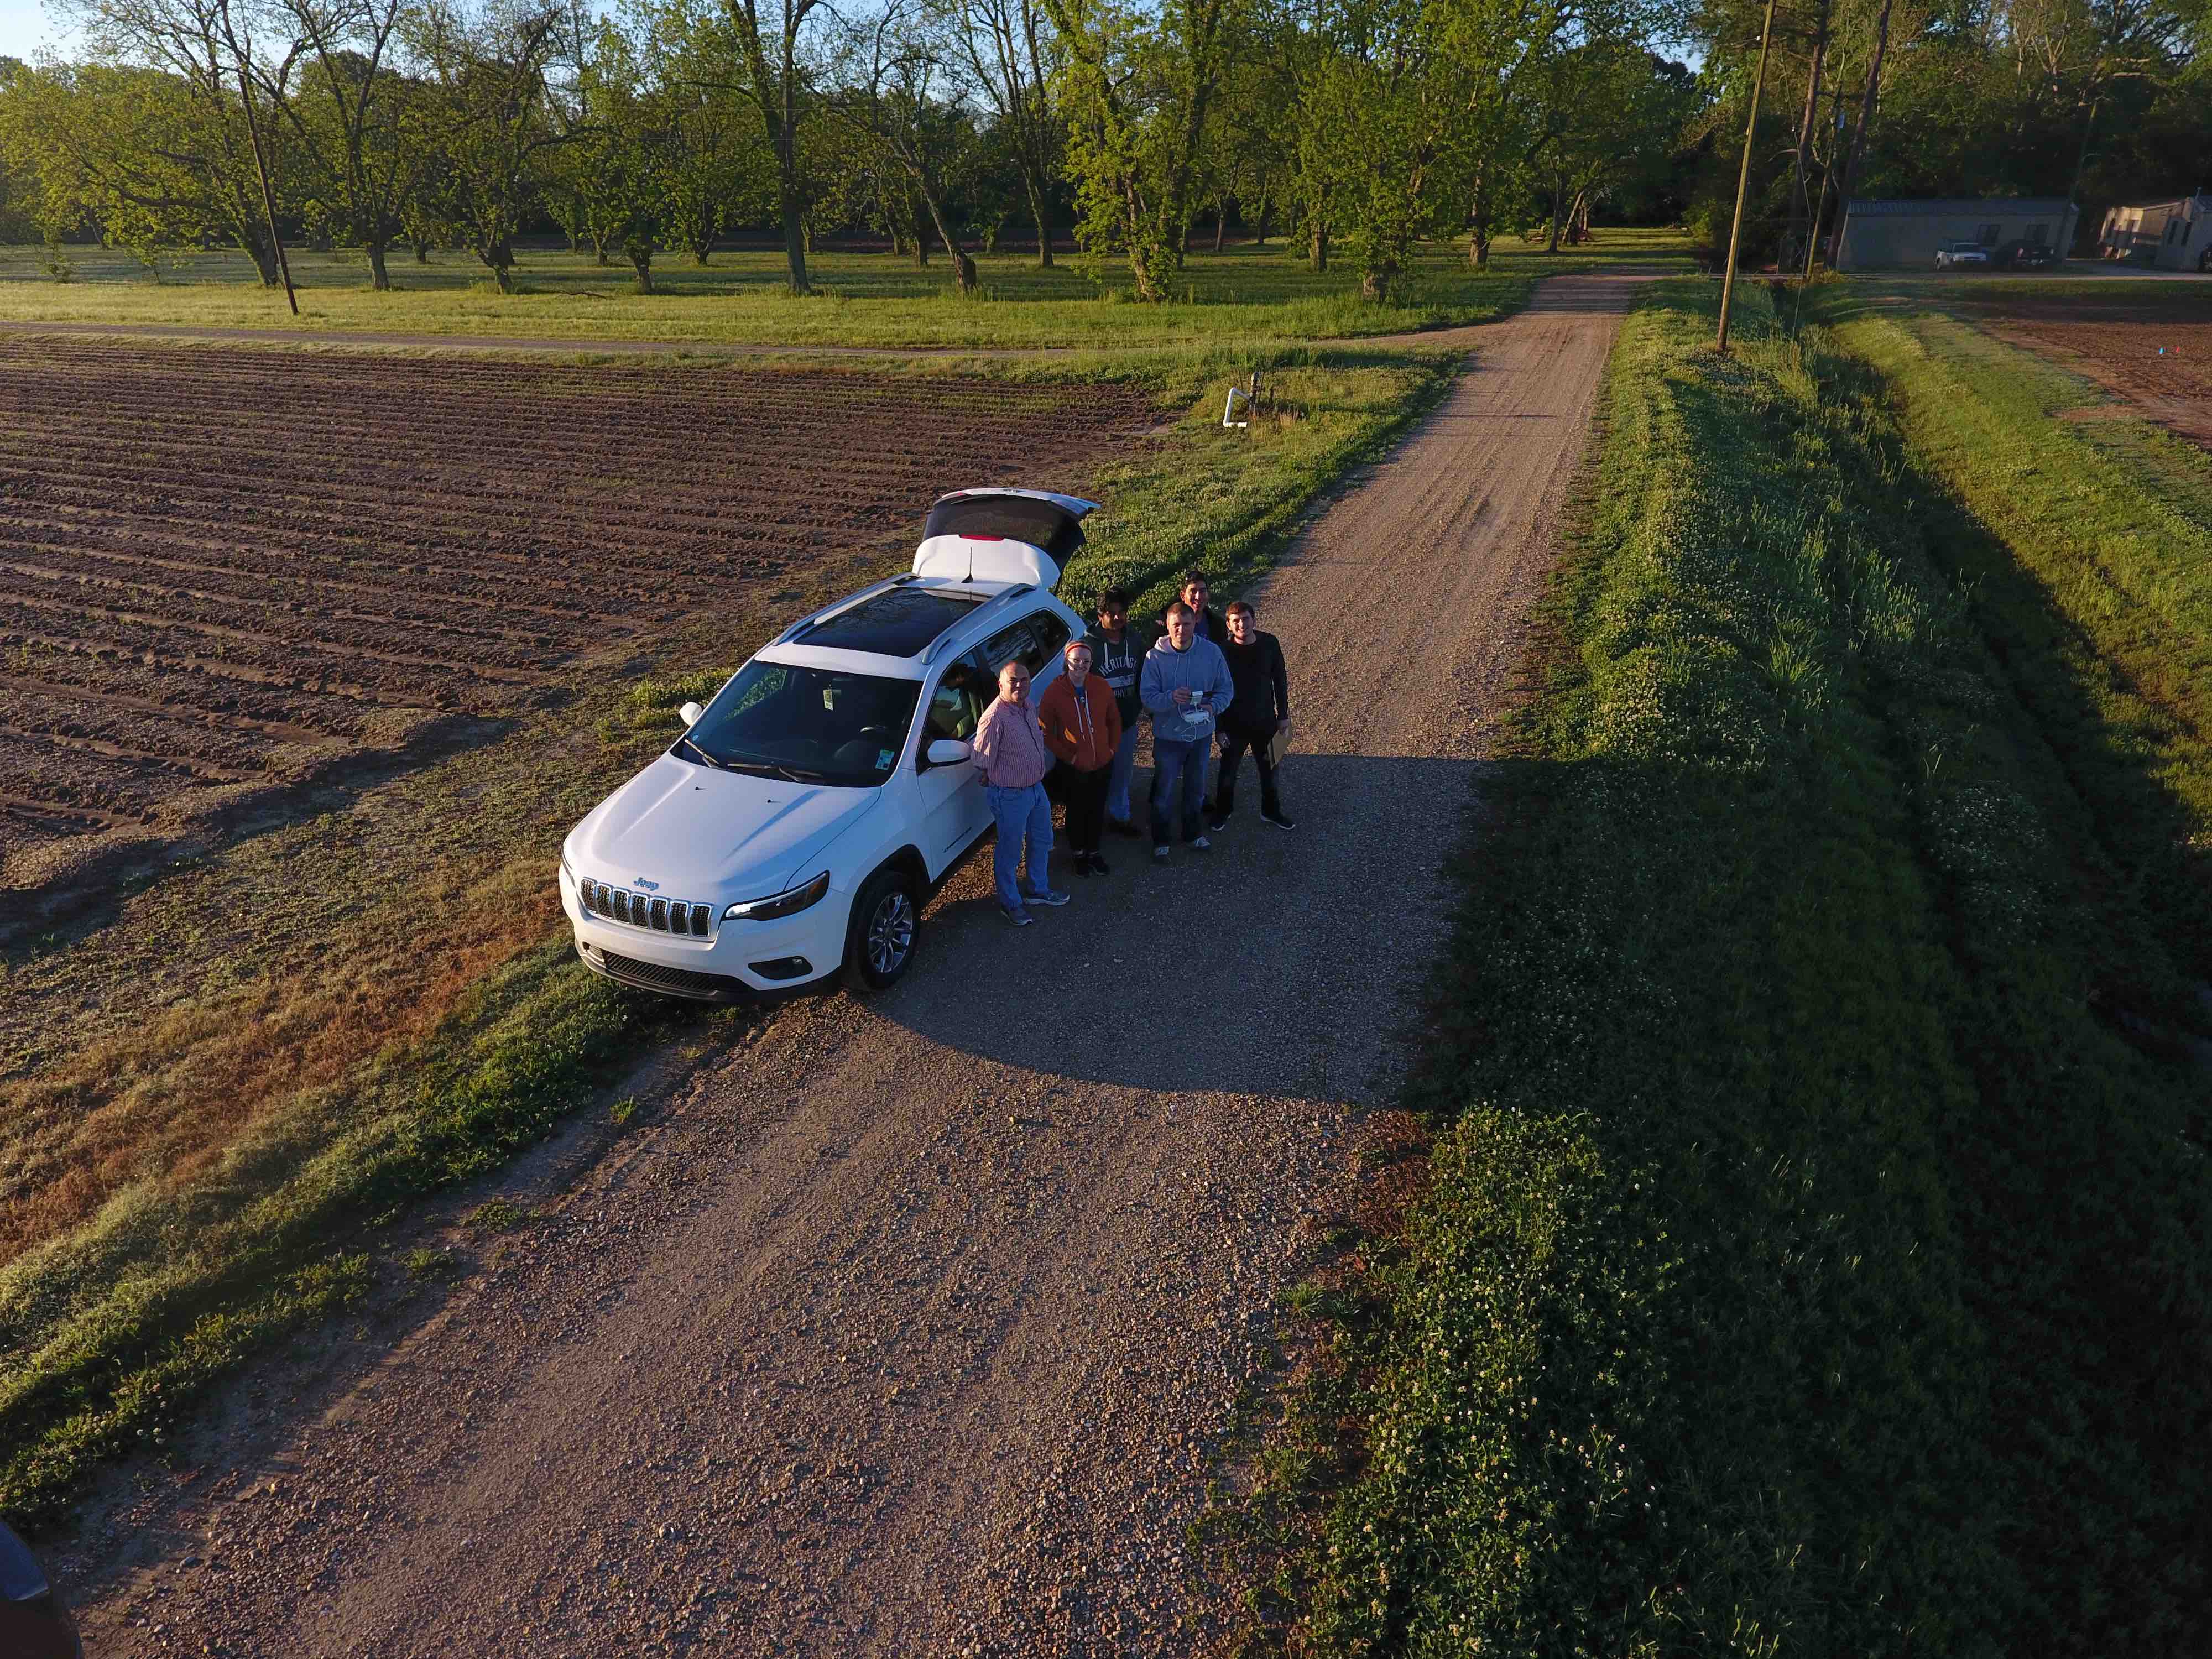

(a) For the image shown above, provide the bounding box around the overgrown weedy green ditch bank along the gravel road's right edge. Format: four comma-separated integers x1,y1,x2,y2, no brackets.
1285,283,2212,1655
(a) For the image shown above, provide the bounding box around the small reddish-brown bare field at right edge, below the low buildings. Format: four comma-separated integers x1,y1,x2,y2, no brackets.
1971,290,2212,447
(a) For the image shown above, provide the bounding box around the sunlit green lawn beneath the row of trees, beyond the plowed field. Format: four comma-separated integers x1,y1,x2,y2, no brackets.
0,230,1688,349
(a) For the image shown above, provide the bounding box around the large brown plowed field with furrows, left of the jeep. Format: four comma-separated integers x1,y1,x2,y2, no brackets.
0,336,1155,911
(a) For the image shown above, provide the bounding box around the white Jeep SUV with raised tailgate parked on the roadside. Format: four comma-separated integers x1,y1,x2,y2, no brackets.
560,489,1097,1002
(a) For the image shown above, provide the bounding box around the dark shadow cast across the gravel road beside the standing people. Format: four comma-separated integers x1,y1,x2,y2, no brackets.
860,754,1478,1102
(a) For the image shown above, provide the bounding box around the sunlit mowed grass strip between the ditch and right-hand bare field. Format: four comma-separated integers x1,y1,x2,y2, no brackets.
1836,303,2212,982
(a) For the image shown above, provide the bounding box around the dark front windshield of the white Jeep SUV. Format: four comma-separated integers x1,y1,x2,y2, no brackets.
670,659,922,790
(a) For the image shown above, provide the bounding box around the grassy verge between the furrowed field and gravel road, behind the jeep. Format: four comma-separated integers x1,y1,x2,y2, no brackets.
0,347,1449,1520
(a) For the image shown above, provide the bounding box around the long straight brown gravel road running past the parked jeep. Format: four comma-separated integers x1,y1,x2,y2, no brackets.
77,276,1632,1659
